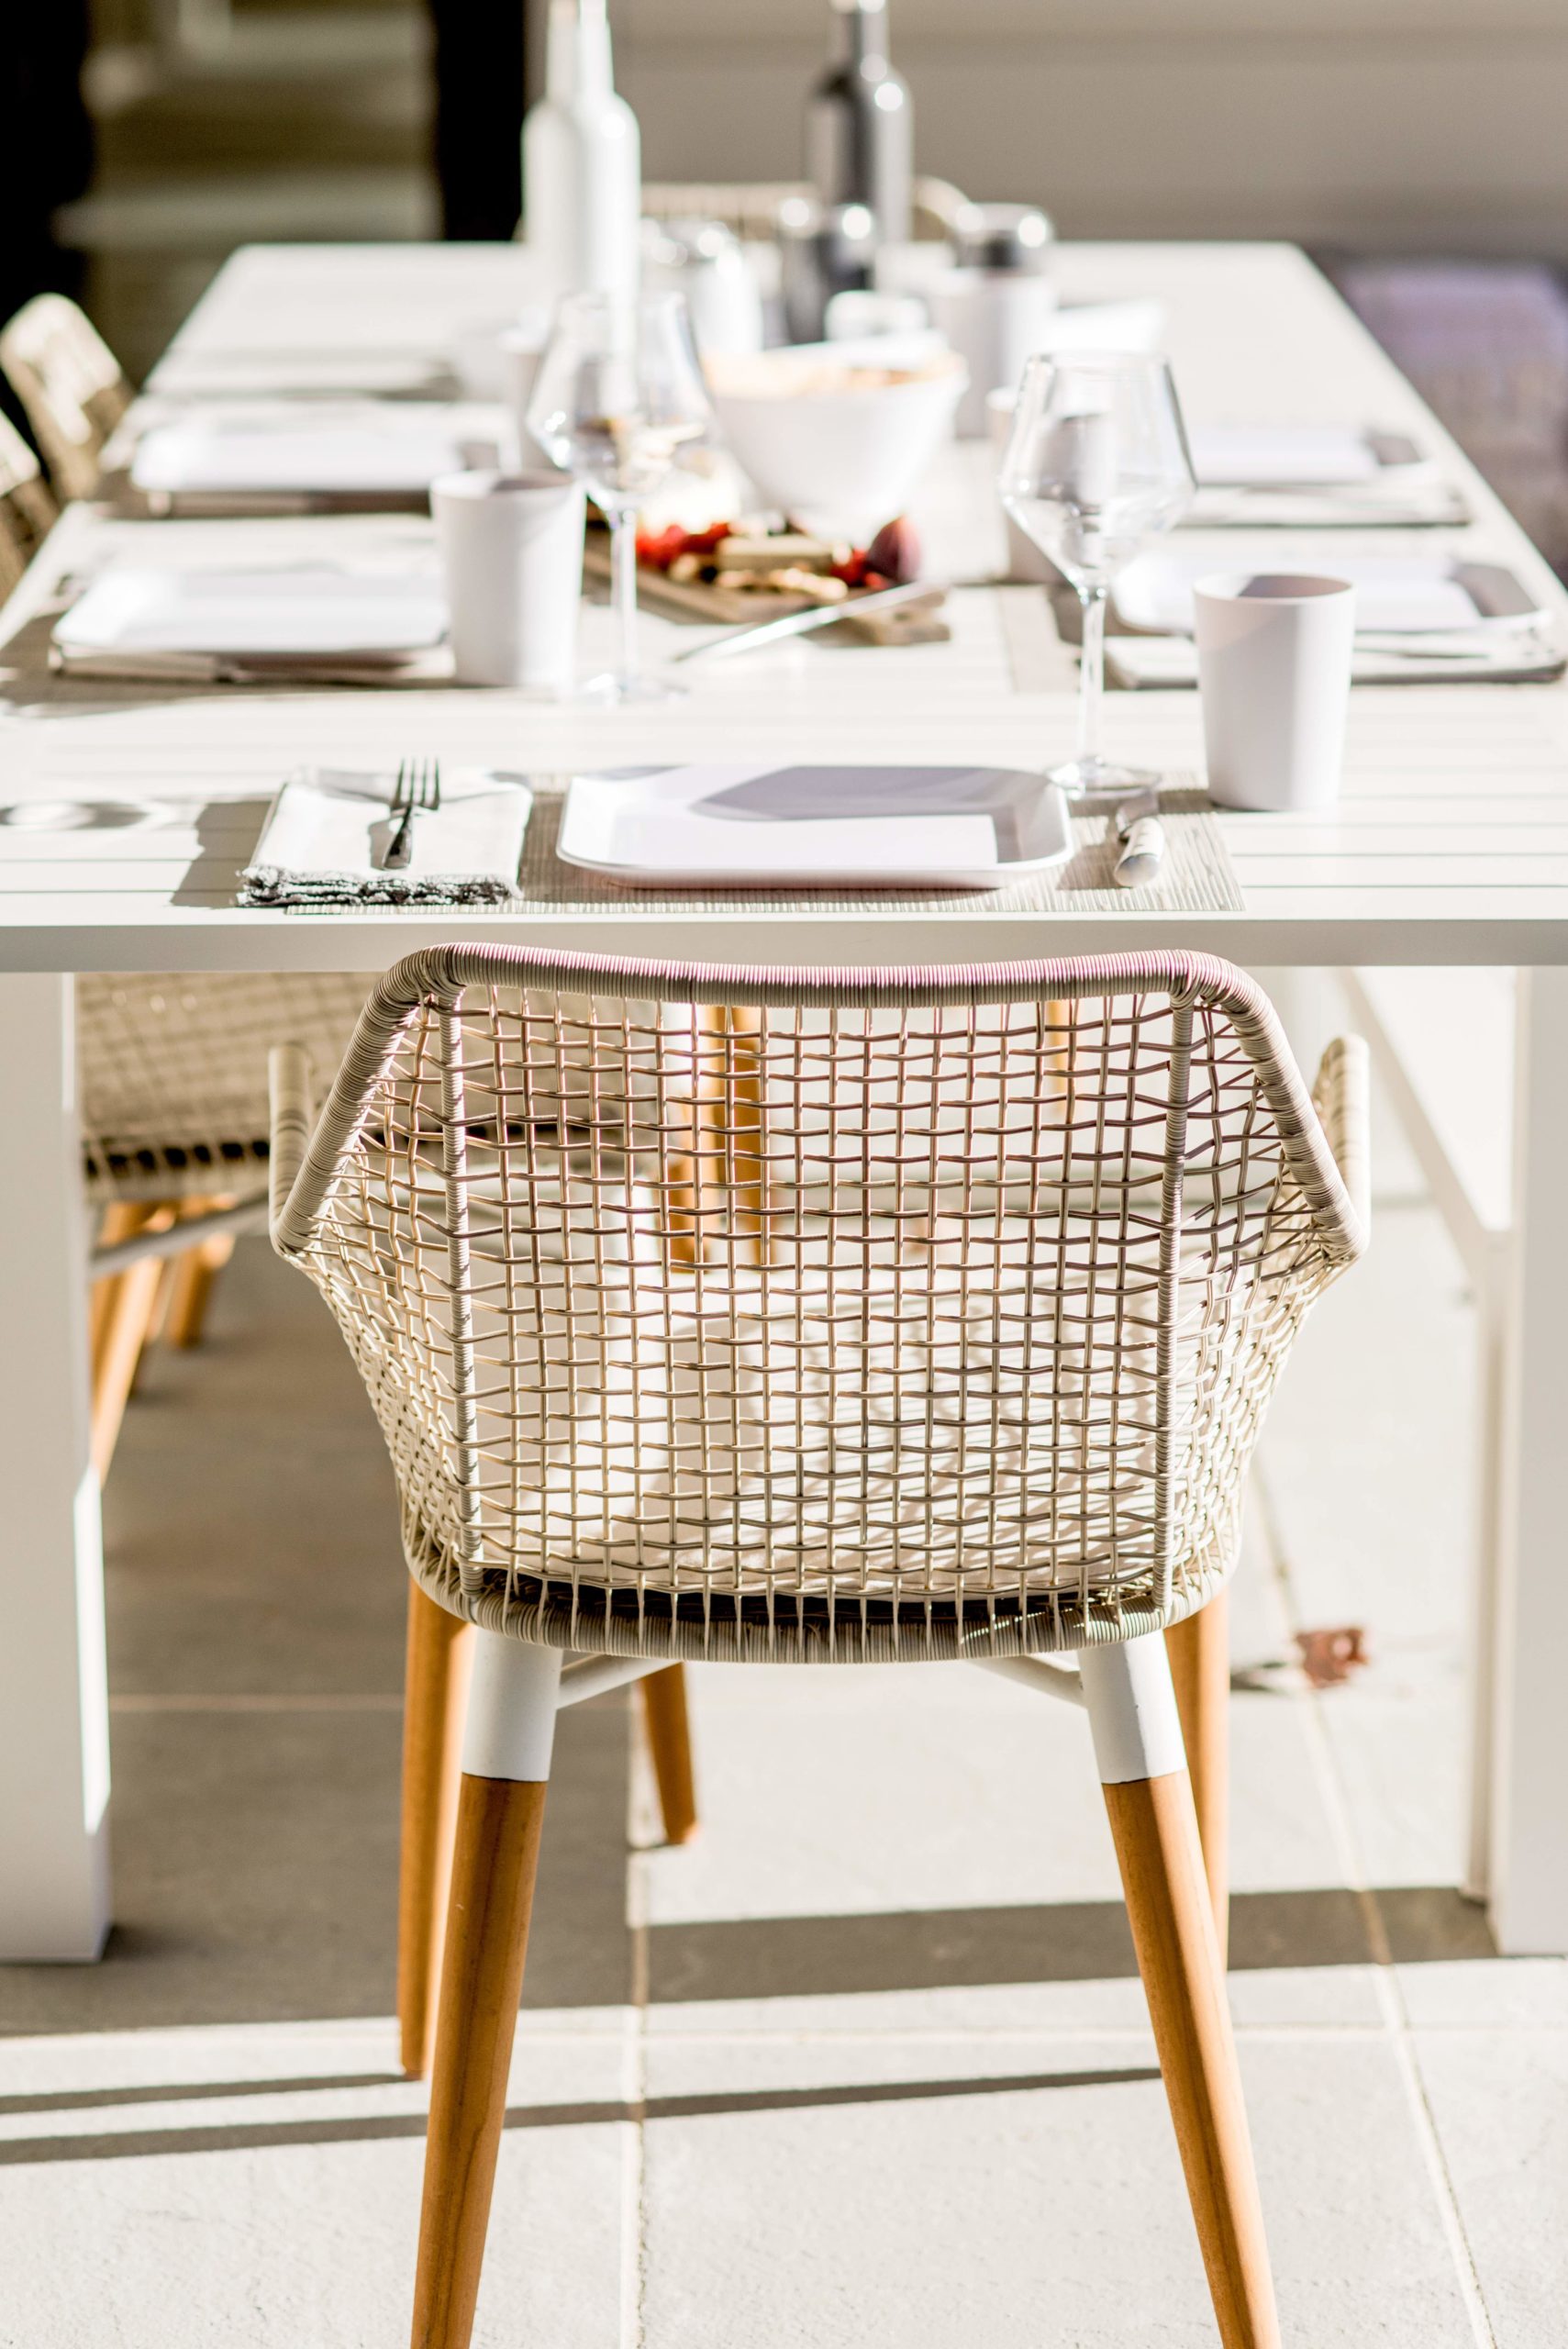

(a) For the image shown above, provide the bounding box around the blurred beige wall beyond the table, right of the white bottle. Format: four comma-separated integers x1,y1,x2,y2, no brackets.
610,0,1568,259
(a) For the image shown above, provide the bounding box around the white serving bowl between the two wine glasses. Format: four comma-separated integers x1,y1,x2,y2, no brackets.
709,339,967,536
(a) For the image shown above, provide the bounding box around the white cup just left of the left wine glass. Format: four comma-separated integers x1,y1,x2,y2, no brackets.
429,470,584,693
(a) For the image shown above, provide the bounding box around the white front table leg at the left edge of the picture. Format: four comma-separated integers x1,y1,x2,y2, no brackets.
0,974,108,1959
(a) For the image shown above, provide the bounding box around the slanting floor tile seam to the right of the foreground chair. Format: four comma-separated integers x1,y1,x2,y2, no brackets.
1253,1456,1497,2349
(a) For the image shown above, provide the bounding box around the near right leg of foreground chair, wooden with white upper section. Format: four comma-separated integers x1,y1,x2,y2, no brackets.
1080,1632,1279,2349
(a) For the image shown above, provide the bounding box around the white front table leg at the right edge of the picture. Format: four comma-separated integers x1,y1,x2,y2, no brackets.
1491,970,1568,1956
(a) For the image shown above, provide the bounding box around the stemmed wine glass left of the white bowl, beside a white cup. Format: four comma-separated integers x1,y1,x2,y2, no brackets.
528,294,711,702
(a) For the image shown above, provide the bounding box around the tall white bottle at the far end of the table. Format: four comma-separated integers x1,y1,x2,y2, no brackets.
524,0,643,301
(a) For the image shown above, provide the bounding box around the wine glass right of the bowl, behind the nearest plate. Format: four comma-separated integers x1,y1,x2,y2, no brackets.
997,352,1195,798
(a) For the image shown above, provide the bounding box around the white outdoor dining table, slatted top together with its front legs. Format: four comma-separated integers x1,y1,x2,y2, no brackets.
0,244,1568,1959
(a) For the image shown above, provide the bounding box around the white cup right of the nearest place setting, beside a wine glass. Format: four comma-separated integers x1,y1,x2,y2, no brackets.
1193,571,1357,813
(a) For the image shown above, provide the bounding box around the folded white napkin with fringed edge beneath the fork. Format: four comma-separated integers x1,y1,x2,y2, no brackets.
239,766,533,907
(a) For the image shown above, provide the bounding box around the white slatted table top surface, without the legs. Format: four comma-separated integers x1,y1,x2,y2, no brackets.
0,244,1568,970
